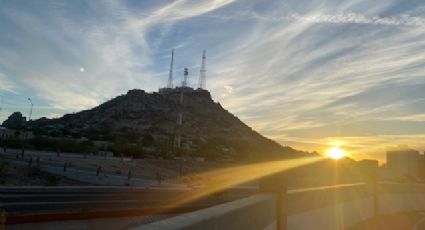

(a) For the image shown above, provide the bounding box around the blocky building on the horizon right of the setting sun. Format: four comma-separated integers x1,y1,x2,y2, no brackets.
386,145,424,176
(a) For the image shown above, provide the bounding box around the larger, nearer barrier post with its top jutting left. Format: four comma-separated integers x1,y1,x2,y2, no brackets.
259,172,288,230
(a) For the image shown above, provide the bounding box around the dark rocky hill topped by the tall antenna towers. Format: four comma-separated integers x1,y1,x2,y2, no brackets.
5,88,312,161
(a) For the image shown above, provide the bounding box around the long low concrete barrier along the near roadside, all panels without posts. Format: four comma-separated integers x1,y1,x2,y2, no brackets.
133,184,425,230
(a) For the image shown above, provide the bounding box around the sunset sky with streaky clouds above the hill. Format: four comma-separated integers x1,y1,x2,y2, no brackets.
0,0,425,161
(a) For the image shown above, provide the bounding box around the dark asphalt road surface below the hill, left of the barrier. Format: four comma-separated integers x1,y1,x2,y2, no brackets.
0,186,255,224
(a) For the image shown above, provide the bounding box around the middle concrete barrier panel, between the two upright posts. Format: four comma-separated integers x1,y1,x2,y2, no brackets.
282,184,374,230
